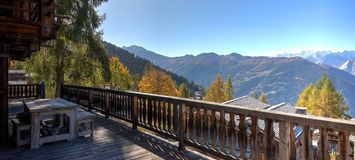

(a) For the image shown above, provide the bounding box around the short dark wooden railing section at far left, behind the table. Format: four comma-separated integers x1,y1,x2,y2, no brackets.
8,83,45,99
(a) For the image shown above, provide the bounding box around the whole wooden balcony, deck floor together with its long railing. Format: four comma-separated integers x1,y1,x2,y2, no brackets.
0,85,355,160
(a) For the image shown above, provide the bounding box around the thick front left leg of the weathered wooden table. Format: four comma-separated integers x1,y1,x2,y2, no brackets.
31,113,40,149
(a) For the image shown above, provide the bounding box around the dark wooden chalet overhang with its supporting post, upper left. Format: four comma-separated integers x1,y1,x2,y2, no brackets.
0,0,58,142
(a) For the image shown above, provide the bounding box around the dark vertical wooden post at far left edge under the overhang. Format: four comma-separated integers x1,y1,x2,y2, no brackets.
0,44,9,144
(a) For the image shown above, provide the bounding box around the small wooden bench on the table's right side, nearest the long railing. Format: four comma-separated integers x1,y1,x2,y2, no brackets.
76,107,95,138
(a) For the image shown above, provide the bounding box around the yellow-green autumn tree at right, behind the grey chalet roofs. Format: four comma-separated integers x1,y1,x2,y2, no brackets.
297,75,349,119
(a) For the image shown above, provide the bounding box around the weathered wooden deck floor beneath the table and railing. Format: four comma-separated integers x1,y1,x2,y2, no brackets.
0,112,213,160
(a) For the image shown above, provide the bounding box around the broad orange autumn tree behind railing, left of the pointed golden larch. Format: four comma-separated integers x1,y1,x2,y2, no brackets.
138,65,179,96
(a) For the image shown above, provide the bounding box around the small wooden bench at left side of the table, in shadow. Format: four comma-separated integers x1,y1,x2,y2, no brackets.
11,114,31,147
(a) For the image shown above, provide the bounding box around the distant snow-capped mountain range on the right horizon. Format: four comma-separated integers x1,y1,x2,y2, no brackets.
278,51,355,75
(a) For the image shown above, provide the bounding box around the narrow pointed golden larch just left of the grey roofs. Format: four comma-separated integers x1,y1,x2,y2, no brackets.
203,74,225,103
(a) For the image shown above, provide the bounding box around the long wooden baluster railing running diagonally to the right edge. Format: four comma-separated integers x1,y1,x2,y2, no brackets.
61,85,355,160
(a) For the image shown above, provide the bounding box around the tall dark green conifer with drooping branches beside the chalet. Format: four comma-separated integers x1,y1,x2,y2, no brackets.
52,0,111,96
